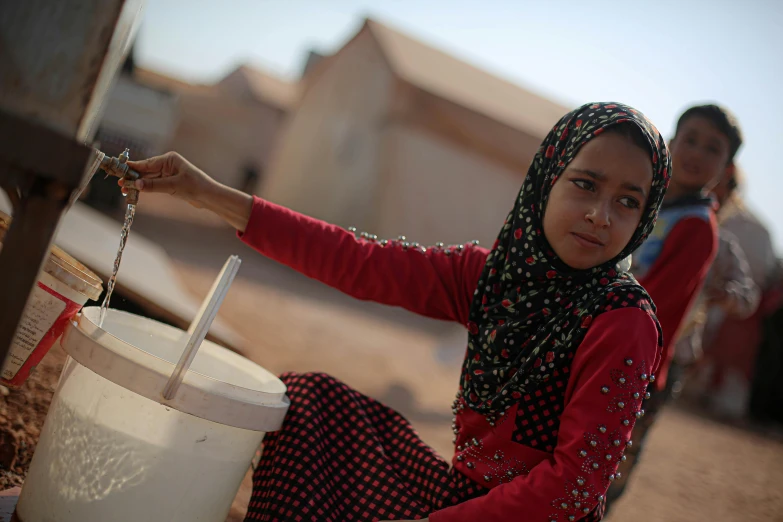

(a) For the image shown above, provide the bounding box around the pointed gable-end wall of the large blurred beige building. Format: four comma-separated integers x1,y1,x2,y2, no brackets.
262,29,394,227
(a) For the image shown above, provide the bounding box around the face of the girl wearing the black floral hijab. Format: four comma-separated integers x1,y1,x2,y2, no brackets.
544,132,653,270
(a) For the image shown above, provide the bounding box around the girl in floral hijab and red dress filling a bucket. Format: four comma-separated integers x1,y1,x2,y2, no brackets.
129,99,670,522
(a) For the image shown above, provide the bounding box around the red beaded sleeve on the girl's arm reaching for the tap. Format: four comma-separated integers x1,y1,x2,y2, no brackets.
239,198,489,324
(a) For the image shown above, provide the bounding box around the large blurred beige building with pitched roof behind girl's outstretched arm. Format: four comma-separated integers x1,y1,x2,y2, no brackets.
261,20,568,244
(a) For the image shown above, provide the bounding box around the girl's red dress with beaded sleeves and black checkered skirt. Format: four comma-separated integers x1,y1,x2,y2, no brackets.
240,198,661,522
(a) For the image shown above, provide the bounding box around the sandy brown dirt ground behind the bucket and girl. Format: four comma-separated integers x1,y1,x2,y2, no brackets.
0,198,783,522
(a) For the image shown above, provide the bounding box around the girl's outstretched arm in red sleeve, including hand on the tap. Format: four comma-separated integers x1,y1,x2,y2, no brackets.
128,152,489,324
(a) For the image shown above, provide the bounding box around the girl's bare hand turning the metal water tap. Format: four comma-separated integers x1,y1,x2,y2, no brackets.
119,152,218,208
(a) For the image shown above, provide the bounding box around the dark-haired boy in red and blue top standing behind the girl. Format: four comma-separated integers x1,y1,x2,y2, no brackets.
607,101,742,509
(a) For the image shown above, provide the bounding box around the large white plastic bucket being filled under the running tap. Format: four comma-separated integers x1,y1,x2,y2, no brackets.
17,307,289,522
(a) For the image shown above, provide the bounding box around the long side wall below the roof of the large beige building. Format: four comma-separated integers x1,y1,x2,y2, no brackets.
371,123,522,246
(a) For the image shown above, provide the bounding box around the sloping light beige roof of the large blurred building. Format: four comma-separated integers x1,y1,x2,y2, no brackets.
362,19,570,137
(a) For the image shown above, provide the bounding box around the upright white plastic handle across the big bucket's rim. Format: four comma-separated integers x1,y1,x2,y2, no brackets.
163,256,242,400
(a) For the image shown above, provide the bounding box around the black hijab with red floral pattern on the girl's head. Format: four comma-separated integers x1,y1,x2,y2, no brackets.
461,103,671,413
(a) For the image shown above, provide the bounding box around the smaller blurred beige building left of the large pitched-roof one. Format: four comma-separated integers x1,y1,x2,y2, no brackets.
134,66,298,190
